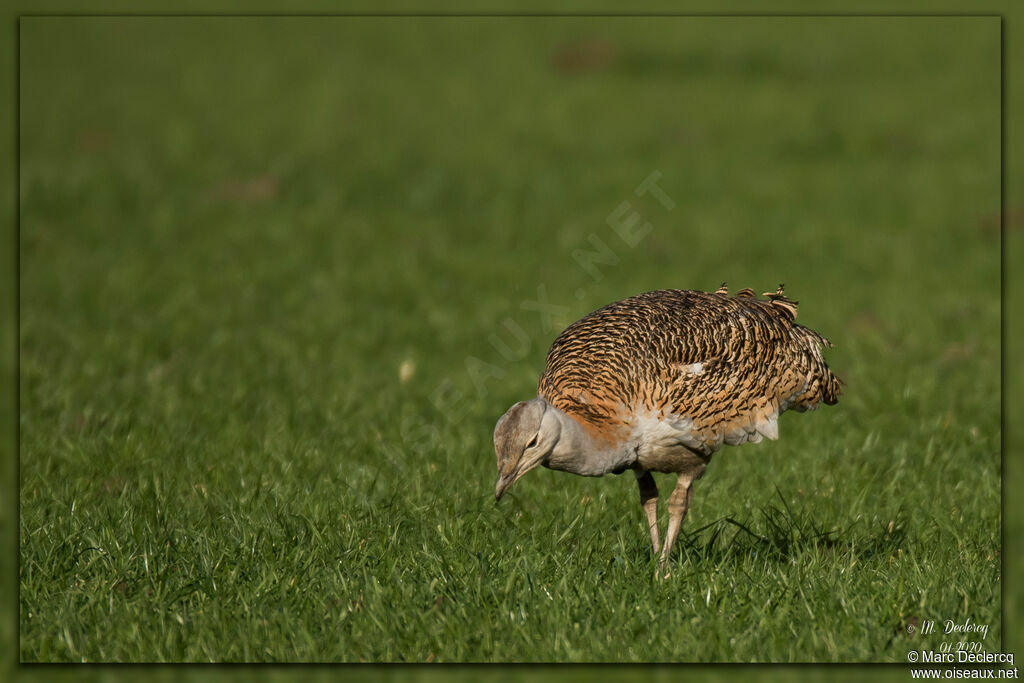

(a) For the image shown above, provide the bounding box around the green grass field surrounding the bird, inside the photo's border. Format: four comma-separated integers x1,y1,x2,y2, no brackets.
18,17,1002,663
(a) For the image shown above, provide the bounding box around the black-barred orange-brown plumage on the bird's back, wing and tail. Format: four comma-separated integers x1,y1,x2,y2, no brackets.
538,288,839,452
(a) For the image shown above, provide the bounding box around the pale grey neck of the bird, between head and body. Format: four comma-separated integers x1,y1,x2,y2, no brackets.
544,403,636,477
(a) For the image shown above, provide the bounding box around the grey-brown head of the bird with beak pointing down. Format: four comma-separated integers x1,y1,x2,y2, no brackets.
495,397,561,501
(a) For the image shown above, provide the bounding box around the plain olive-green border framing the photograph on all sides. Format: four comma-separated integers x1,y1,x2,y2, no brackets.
6,5,1024,683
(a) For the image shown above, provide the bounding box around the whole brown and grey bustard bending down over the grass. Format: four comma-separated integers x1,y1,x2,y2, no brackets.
494,283,842,566
